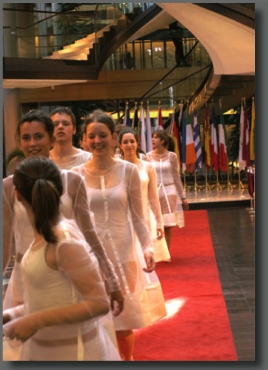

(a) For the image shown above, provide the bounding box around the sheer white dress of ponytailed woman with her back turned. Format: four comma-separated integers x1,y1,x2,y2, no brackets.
7,219,120,361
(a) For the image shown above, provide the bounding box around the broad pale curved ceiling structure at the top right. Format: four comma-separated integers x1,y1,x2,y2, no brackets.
157,3,255,75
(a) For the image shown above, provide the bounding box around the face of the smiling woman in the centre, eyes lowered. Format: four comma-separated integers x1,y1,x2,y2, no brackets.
86,122,114,156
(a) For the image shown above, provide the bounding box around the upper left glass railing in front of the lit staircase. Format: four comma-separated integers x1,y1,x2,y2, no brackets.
3,3,153,60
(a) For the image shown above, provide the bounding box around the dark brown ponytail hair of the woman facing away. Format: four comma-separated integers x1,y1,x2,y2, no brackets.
13,157,63,243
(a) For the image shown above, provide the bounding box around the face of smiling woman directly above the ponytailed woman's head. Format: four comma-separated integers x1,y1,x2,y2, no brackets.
19,121,52,158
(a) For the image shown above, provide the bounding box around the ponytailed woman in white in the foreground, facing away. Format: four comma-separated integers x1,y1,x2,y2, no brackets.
3,157,120,361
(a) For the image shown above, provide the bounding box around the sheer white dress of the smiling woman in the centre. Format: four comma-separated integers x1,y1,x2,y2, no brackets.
72,159,166,330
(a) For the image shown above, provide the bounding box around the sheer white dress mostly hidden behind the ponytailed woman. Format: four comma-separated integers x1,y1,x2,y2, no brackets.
3,170,120,309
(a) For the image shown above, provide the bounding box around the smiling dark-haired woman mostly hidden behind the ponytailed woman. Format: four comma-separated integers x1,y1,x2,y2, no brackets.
3,110,123,314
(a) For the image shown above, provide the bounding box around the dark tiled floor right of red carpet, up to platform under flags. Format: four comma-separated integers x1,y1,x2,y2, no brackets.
193,190,255,361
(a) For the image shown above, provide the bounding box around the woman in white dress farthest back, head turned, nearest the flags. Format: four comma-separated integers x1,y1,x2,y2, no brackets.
147,130,189,256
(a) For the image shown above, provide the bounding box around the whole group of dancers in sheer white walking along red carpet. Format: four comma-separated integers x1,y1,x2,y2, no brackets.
3,107,188,361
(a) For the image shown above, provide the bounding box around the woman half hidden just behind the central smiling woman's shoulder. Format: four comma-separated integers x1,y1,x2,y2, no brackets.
118,128,170,262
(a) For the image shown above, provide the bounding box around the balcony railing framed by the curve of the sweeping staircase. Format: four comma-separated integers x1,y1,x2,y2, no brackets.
103,37,211,109
